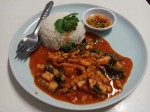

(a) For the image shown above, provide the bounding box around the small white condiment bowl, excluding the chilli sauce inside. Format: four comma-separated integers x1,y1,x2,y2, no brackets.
82,7,117,31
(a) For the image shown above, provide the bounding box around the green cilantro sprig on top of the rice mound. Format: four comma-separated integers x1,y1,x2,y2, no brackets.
54,13,79,33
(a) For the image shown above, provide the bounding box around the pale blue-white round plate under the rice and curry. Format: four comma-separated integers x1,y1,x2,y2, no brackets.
9,4,148,110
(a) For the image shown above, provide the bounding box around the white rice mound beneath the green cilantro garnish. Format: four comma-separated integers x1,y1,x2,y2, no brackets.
39,12,85,50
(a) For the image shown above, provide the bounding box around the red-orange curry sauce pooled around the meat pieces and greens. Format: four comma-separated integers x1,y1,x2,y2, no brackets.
30,32,133,104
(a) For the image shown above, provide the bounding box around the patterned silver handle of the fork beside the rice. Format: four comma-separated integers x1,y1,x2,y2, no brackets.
33,1,54,34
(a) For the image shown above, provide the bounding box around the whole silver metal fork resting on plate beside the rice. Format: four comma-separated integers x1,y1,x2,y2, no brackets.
16,1,54,59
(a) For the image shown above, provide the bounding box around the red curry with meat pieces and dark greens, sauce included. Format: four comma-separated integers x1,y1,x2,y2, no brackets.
30,32,133,104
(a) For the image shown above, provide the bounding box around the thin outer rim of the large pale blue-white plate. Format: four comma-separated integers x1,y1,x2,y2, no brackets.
8,3,148,110
